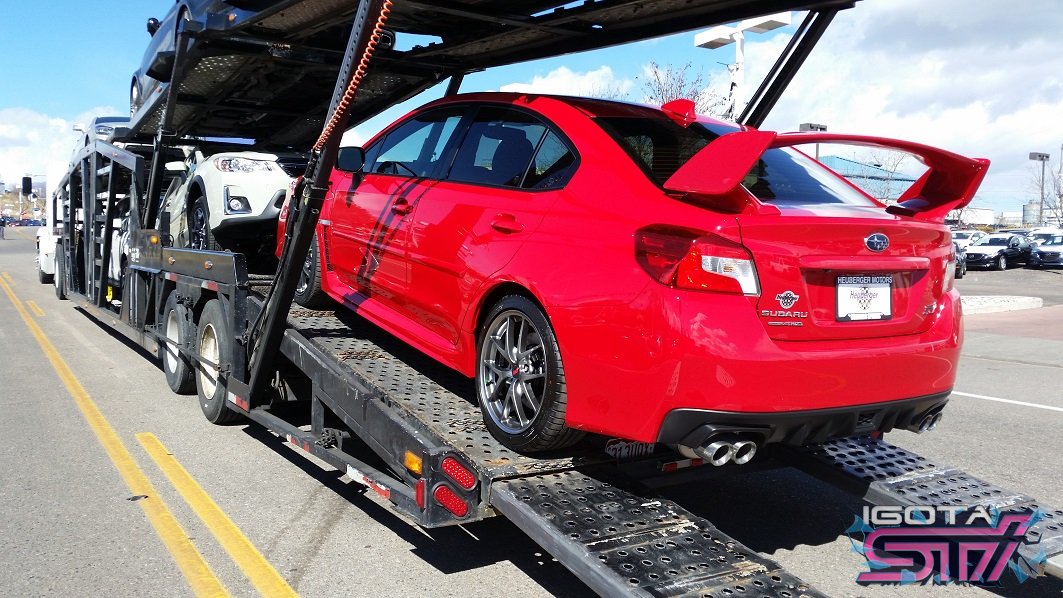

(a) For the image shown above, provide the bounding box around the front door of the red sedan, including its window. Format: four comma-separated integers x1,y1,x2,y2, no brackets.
326,108,462,309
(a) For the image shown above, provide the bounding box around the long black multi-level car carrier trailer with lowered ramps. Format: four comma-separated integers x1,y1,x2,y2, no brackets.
47,0,1063,596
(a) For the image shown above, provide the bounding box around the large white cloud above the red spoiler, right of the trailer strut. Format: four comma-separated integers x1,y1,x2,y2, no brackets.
746,0,1063,211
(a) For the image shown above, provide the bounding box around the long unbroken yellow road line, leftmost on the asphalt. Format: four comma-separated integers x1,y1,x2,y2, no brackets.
0,279,229,596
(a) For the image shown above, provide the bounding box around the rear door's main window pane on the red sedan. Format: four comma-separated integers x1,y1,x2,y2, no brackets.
448,107,546,187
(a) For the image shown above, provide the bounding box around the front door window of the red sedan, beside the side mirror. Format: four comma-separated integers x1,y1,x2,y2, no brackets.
366,108,463,178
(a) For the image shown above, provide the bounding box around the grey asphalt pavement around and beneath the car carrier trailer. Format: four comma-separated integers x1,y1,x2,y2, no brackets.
0,228,1063,596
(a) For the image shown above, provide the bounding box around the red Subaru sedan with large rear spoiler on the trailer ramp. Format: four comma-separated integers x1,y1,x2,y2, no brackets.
281,93,989,464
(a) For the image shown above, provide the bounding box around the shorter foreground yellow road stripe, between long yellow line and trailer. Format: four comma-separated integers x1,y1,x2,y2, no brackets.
136,432,299,596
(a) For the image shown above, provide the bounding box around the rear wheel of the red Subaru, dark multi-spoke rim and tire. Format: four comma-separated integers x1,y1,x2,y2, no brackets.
476,295,584,452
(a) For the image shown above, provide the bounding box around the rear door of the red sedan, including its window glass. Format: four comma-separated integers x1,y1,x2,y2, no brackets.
407,107,576,351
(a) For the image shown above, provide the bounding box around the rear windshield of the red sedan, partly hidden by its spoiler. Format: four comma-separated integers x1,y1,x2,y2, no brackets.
595,115,876,206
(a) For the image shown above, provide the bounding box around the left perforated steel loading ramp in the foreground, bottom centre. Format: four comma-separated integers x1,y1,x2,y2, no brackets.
493,471,824,598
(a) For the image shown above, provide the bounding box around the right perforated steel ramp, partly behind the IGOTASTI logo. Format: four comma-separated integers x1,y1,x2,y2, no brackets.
780,437,1063,578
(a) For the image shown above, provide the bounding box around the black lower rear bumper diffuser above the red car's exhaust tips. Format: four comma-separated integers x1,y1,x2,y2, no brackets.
657,392,949,446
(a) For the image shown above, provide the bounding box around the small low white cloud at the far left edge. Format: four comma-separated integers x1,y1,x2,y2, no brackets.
0,106,121,190
